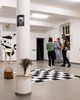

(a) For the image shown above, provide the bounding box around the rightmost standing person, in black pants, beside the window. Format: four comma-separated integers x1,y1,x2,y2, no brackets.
61,34,71,68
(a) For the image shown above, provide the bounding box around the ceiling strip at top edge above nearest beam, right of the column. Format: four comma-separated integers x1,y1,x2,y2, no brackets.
31,0,80,11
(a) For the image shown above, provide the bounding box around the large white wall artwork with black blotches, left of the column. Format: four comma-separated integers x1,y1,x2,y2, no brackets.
1,32,16,60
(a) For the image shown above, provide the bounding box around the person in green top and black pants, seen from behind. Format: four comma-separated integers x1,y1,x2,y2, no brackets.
46,37,55,67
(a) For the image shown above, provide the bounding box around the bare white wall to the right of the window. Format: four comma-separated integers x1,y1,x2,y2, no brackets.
70,19,80,63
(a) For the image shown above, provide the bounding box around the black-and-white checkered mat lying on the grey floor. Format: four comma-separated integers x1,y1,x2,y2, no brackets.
31,69,80,83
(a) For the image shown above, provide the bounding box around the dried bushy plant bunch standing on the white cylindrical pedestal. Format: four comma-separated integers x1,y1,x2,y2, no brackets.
20,58,32,74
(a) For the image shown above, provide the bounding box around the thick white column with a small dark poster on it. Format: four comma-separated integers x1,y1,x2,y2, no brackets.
17,0,30,61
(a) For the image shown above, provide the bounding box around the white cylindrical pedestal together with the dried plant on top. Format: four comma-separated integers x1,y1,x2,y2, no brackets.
15,58,32,94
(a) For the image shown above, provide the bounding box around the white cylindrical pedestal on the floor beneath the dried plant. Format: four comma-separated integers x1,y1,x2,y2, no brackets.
15,74,32,94
